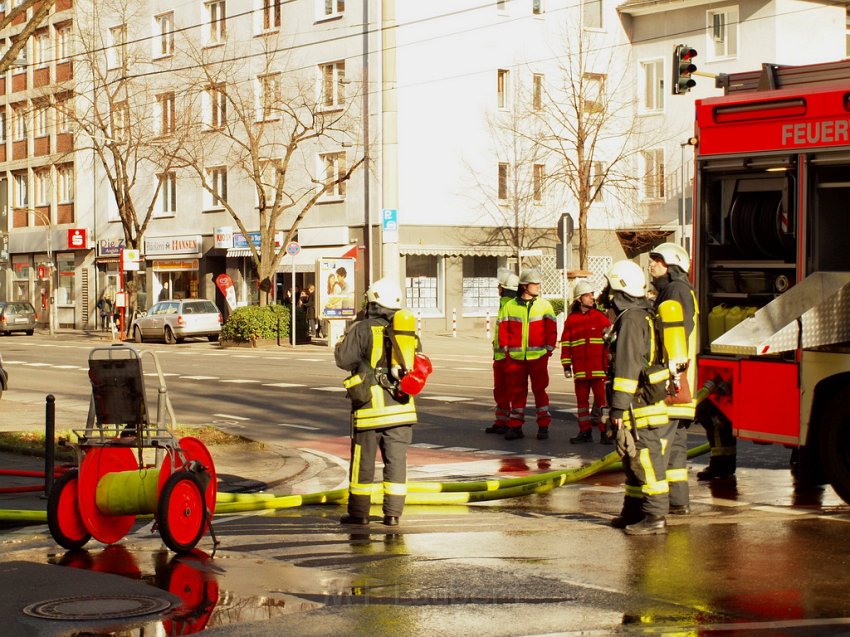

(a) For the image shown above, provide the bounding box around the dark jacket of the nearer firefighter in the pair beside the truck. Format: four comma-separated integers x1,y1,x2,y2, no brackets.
608,292,670,427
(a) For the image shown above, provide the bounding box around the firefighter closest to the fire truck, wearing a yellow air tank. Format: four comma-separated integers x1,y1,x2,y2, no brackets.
649,243,699,515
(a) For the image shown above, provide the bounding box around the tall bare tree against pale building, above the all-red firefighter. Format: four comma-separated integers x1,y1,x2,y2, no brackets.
537,27,658,270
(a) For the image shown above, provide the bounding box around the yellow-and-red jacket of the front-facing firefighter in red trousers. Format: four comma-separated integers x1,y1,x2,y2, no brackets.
496,297,558,360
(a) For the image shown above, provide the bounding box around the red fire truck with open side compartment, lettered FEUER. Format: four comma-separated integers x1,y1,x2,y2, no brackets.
693,60,850,503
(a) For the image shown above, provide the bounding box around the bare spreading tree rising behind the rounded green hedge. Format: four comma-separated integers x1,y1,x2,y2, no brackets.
178,39,365,302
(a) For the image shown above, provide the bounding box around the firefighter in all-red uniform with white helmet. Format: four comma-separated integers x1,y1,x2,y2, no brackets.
561,281,611,444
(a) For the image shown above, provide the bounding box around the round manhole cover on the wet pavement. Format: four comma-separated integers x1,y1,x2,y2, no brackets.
24,595,171,621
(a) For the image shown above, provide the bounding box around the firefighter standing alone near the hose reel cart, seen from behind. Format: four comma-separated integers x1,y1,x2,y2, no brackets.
334,279,420,526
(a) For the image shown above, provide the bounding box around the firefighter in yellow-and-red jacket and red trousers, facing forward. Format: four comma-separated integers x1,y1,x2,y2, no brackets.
496,268,558,440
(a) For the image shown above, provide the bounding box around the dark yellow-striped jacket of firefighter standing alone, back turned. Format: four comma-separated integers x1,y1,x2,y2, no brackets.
334,313,420,429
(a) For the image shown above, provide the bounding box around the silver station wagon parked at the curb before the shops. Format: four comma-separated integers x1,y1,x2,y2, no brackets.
133,299,222,344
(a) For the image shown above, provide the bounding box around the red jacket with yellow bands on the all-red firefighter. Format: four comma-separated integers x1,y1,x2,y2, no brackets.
561,307,611,380
